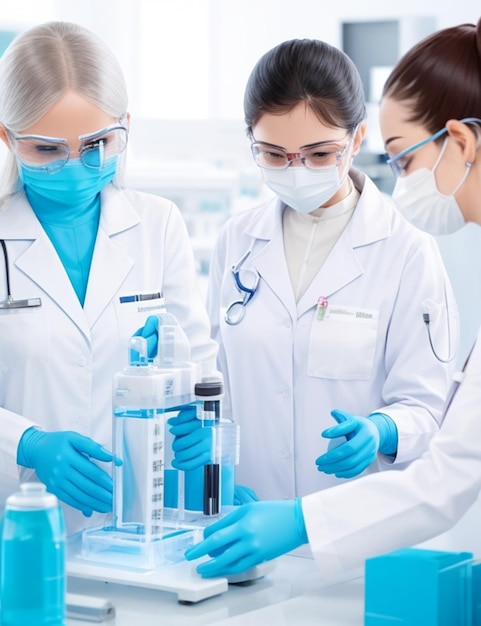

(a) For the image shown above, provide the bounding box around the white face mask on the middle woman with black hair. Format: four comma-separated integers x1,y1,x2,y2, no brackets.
262,165,341,213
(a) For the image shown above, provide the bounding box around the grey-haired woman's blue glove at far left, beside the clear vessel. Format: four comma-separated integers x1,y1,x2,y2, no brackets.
17,427,122,517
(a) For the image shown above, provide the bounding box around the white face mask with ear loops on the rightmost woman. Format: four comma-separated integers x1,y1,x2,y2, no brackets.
392,140,471,235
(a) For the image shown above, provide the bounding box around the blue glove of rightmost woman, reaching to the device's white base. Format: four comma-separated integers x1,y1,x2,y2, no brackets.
185,498,308,578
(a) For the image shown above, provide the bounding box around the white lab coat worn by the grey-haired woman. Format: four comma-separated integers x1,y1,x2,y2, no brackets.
0,185,217,531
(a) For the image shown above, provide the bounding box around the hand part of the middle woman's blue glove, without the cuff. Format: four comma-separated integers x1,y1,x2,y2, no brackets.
316,409,380,478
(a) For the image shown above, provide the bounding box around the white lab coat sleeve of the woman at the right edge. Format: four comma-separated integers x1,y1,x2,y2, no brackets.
302,335,481,579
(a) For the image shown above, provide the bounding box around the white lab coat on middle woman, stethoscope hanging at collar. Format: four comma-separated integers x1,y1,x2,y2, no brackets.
208,170,458,499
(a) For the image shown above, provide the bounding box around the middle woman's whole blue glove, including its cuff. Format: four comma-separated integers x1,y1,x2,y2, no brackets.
316,409,397,478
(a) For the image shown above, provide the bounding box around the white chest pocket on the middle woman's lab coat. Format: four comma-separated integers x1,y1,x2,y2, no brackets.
307,305,379,380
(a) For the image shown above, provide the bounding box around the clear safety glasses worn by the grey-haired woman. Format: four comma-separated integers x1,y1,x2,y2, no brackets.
9,119,128,174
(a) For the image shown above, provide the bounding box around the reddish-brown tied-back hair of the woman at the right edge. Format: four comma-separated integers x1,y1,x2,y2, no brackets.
383,19,481,133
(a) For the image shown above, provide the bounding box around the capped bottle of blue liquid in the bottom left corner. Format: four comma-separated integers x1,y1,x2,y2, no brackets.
0,483,66,626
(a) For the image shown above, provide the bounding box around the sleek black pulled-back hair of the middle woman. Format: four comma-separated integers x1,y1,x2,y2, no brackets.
244,39,366,135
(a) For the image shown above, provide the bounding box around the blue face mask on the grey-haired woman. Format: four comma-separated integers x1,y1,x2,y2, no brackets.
19,157,117,209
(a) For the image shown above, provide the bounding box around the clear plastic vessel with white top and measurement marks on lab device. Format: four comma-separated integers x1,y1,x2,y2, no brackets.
113,314,196,540
